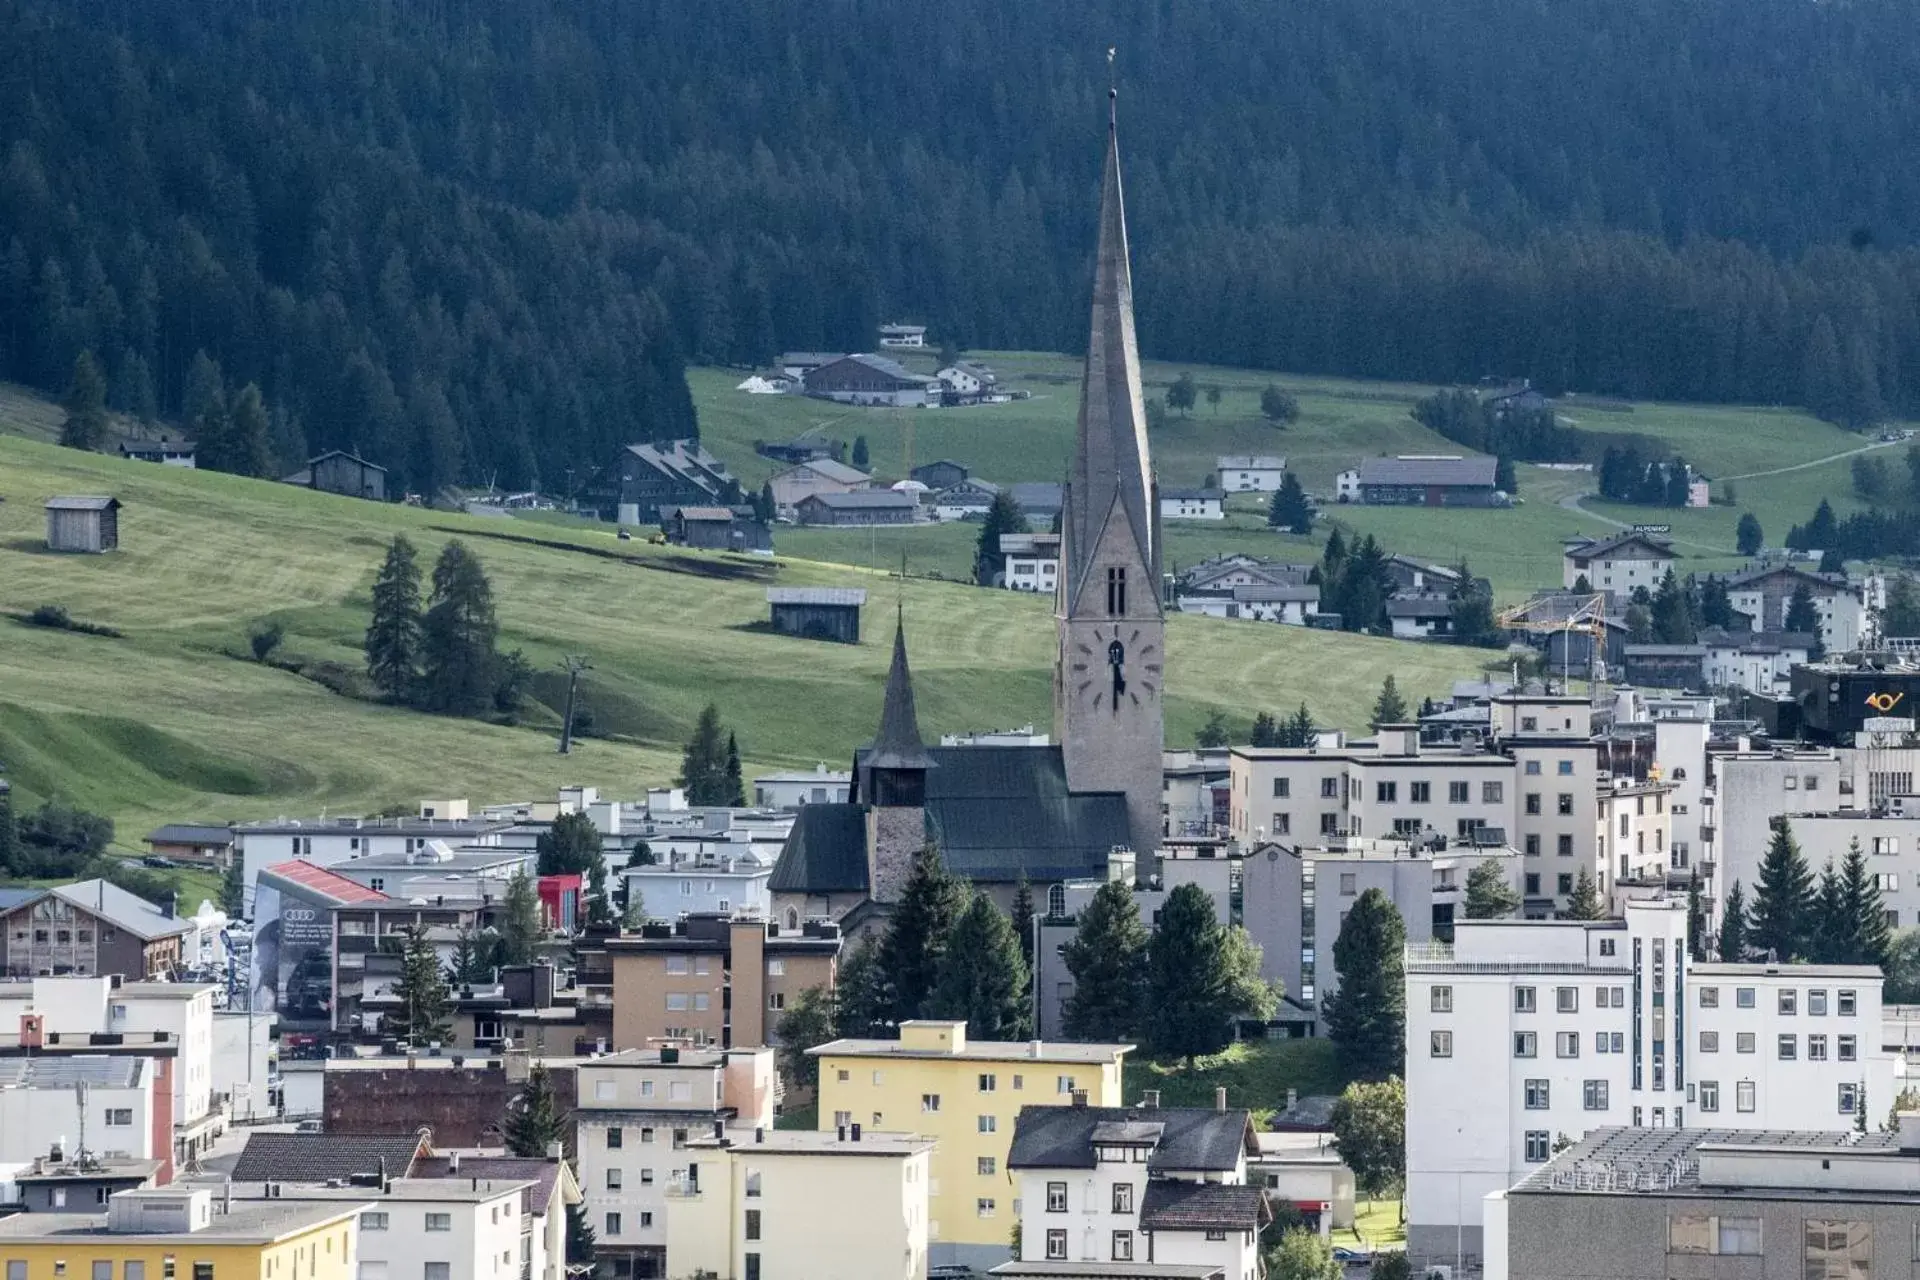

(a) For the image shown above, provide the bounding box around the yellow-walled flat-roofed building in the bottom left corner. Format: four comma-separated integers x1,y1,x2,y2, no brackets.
0,1186,362,1280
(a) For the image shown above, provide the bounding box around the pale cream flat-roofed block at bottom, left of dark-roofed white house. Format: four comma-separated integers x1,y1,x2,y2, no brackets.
666,1128,933,1280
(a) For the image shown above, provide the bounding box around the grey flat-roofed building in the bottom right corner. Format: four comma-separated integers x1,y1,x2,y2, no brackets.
1489,1113,1920,1280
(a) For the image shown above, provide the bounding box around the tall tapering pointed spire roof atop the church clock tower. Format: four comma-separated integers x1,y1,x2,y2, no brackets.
1062,90,1160,610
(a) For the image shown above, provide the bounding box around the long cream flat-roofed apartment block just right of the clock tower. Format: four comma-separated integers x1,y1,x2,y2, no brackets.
1229,717,1613,915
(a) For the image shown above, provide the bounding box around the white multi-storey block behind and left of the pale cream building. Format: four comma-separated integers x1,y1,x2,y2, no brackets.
574,1048,774,1280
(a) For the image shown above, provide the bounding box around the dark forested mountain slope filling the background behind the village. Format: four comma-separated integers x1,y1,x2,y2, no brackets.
0,0,1920,487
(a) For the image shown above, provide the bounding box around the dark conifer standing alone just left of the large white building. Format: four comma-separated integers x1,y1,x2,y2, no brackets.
1321,889,1407,1080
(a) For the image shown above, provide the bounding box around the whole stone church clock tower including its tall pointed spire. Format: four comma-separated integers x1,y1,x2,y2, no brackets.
1054,92,1167,864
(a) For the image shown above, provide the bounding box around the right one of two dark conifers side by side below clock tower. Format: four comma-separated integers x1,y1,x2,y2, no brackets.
1142,885,1238,1065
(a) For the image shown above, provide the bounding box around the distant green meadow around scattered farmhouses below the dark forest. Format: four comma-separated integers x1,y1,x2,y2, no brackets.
689,360,1905,599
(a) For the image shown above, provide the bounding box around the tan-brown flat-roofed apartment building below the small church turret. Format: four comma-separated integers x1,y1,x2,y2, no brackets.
605,915,841,1050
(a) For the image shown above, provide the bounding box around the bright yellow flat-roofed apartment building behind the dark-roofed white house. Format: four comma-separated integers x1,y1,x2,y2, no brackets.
810,1019,1133,1267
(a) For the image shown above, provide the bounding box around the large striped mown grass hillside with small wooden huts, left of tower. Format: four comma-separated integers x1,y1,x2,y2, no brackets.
0,436,1490,846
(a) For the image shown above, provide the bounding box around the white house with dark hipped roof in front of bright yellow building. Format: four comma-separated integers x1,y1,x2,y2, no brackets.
993,1090,1271,1280
